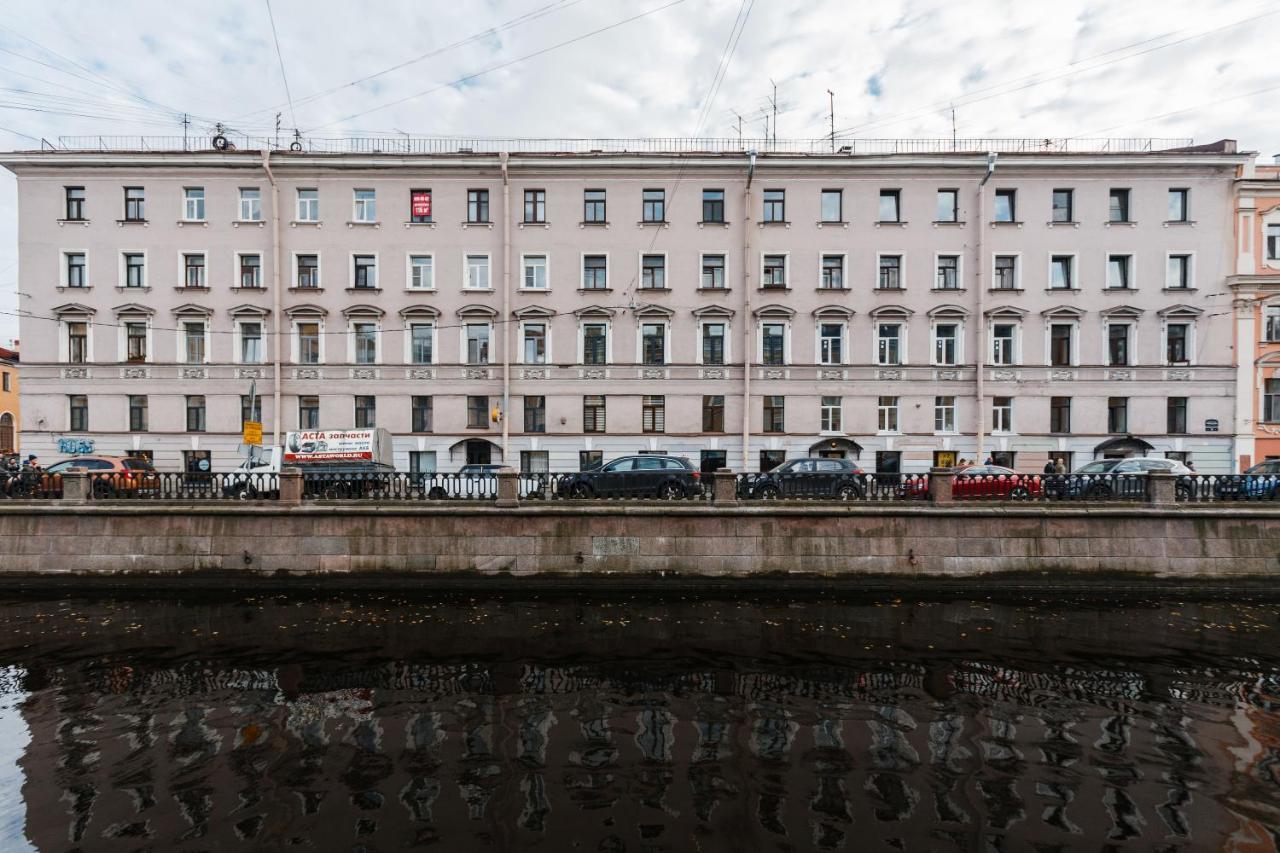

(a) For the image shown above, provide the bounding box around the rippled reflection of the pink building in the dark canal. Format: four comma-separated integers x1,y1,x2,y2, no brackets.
0,594,1280,853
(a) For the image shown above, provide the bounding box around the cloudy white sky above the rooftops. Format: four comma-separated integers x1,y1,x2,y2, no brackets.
0,0,1280,343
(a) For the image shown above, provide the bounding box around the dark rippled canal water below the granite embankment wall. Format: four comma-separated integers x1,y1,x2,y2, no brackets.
0,596,1280,853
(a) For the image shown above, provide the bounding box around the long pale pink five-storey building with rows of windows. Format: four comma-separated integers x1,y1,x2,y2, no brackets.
0,141,1252,471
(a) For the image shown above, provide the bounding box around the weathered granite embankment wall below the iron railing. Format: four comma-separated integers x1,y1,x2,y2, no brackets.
0,502,1280,583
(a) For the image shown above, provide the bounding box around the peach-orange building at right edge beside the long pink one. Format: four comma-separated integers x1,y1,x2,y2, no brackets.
1229,164,1280,470
